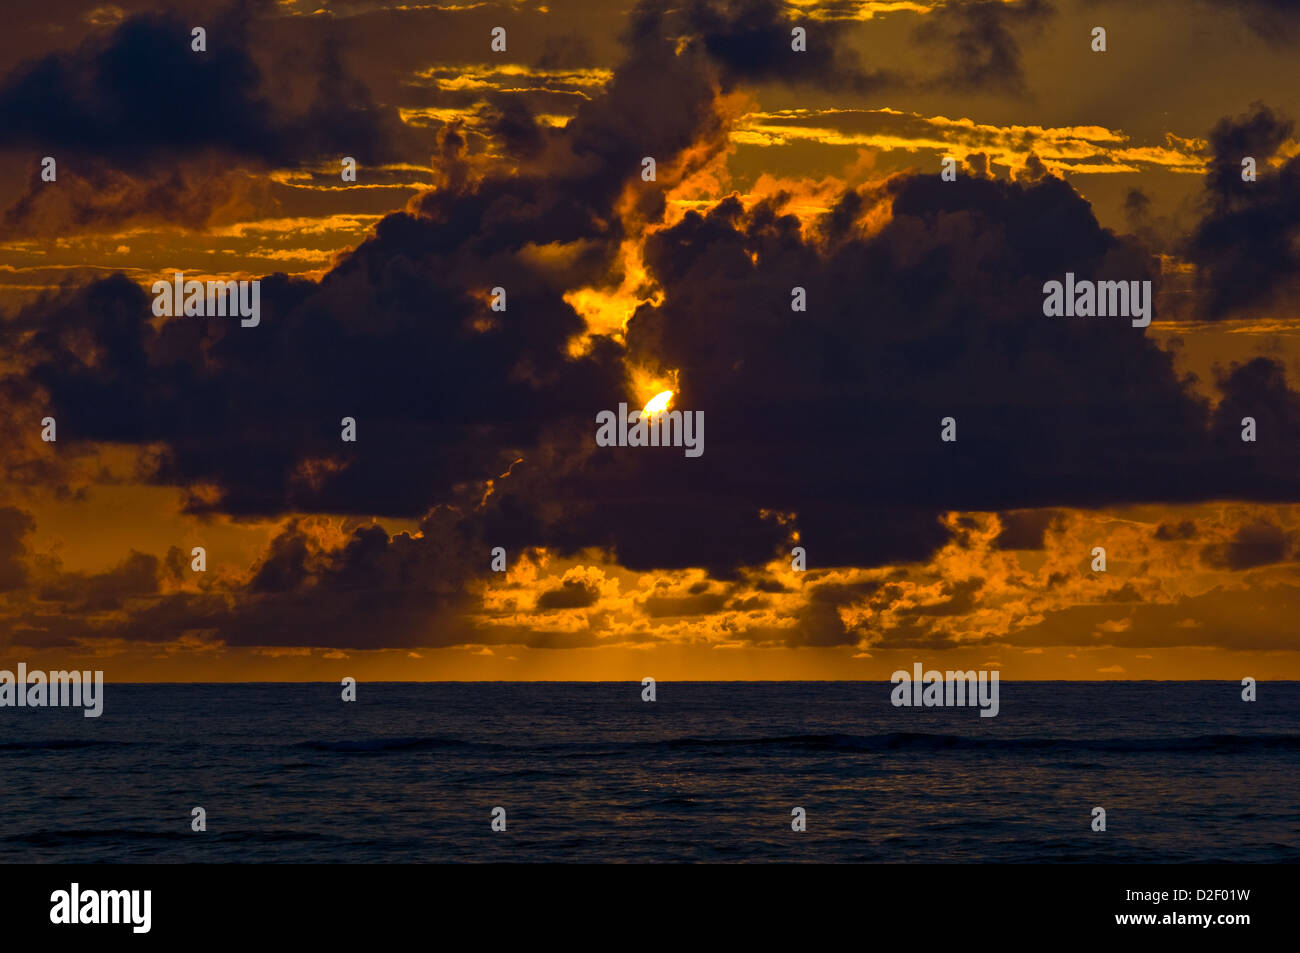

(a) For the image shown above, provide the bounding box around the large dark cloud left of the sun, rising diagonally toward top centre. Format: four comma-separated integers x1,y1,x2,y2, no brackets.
5,0,753,535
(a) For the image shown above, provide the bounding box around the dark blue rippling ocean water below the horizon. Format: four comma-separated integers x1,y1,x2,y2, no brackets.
0,681,1300,863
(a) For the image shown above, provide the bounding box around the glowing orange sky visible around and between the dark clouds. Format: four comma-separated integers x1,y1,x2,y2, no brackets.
0,3,1300,681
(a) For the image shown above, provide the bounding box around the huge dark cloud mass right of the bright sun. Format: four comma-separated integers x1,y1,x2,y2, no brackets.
613,169,1300,556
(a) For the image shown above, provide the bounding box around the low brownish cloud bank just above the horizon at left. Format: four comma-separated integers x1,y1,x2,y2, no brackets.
8,511,490,649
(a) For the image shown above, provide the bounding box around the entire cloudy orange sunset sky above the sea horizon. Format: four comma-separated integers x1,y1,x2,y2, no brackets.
0,0,1300,681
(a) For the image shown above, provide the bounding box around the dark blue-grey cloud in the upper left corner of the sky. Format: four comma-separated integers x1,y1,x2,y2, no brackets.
0,3,432,235
